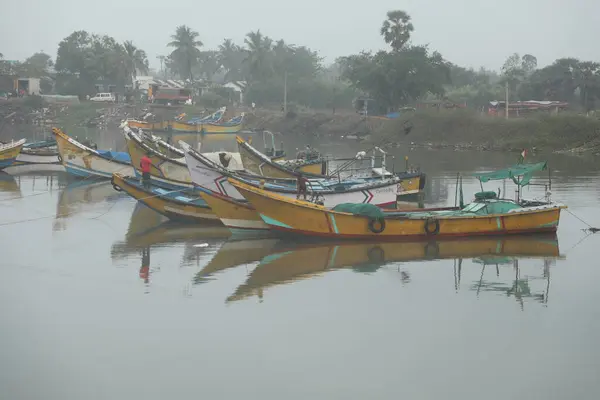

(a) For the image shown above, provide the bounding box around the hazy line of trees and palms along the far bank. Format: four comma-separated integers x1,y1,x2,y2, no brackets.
0,10,600,112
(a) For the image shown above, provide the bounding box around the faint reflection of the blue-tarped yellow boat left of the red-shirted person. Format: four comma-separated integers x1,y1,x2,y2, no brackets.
52,179,126,231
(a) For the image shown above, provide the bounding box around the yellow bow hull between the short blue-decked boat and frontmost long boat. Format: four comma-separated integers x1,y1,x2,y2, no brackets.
200,191,270,233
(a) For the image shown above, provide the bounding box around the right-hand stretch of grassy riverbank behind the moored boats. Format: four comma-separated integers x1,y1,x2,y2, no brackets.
248,110,600,154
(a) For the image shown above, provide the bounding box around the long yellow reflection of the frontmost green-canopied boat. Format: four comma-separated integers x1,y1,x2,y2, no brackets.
227,234,560,302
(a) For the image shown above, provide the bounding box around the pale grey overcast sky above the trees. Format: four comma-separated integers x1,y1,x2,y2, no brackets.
0,0,600,69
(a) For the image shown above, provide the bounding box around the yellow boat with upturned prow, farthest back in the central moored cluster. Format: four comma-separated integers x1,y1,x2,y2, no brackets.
236,136,327,179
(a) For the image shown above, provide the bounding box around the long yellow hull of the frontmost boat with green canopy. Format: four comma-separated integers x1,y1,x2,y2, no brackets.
230,179,564,239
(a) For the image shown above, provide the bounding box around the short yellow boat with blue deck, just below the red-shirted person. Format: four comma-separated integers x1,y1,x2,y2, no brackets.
111,173,220,224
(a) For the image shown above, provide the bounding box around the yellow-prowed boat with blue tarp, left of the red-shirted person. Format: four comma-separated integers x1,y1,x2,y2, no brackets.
52,128,134,179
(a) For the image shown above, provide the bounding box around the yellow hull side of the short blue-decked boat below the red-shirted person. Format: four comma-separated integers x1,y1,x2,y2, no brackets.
112,174,220,223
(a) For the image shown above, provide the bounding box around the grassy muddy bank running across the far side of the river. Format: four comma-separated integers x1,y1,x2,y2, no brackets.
0,103,600,155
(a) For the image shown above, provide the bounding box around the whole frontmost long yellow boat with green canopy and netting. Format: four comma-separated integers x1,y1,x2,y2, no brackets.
229,162,566,239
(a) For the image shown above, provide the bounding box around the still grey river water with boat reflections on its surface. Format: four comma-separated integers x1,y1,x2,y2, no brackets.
0,130,600,400
